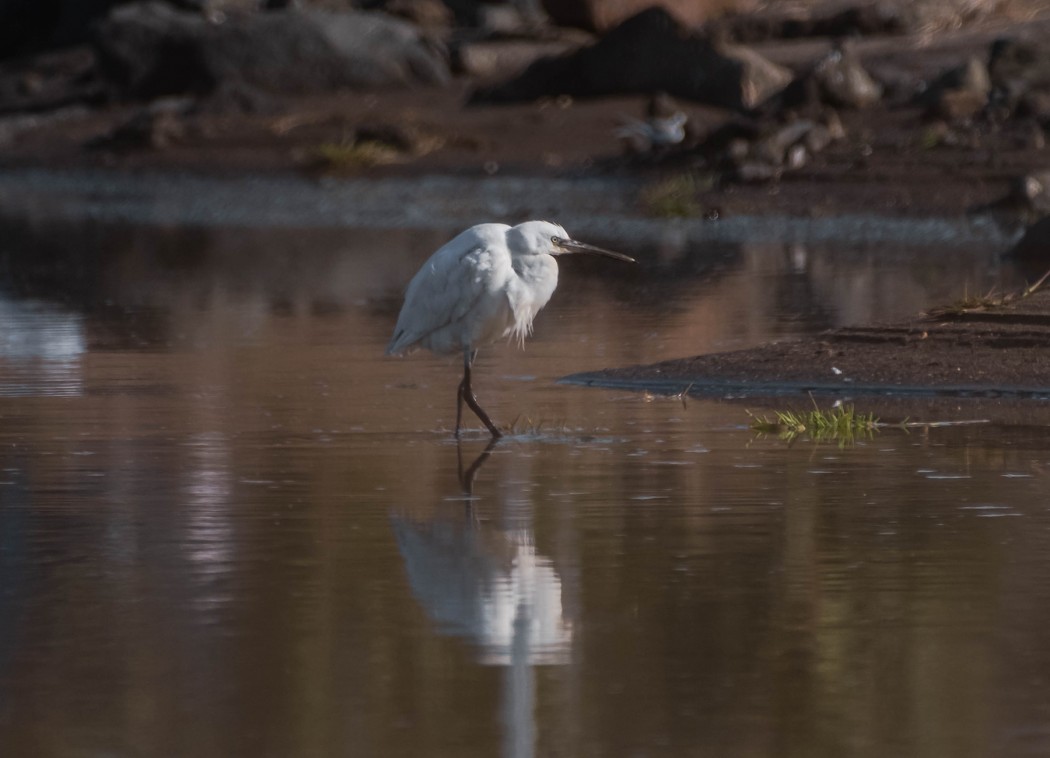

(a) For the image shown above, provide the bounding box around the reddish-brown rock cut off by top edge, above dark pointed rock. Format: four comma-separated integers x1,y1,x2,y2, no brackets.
543,0,757,31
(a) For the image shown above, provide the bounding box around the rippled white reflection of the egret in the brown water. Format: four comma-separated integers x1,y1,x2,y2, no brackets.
392,440,572,756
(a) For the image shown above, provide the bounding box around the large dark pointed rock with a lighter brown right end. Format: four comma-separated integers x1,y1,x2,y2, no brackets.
473,8,788,109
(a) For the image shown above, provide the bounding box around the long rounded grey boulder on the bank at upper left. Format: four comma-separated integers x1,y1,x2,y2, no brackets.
95,2,449,98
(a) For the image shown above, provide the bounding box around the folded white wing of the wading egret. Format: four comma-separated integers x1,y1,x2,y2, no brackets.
386,233,509,355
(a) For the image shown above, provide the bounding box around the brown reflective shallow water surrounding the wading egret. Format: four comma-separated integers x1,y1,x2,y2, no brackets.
0,215,1050,757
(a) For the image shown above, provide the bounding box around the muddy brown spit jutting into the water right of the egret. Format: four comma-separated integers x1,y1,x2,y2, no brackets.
562,281,1050,400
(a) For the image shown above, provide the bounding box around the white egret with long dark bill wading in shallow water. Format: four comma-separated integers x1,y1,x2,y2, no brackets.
386,222,634,438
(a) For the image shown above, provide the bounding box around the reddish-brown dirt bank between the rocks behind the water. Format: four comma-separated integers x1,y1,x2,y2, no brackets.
0,14,1050,216
